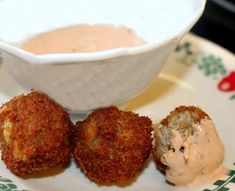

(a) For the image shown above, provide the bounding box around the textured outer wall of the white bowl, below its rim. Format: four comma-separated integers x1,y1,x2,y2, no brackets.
2,41,176,112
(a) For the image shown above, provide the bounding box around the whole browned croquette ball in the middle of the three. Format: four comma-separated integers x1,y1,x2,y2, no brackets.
74,107,153,185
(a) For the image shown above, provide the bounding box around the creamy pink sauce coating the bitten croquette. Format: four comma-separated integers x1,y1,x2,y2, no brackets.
162,119,228,187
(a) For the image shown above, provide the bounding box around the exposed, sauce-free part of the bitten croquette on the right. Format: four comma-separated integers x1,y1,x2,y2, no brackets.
152,106,210,172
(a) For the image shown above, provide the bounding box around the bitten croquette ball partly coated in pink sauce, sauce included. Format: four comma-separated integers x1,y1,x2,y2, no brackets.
153,106,224,186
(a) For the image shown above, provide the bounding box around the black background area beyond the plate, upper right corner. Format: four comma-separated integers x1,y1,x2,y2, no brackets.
191,0,235,53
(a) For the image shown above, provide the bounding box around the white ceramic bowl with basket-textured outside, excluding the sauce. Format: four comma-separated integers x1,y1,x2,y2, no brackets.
0,0,205,112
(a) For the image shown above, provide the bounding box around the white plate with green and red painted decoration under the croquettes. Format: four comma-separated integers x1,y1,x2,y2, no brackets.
0,35,235,191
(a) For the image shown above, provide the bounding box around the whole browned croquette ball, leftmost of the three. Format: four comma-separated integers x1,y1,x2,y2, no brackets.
0,92,73,176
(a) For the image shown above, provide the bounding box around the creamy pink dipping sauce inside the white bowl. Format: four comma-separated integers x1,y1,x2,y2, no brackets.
21,24,144,54
